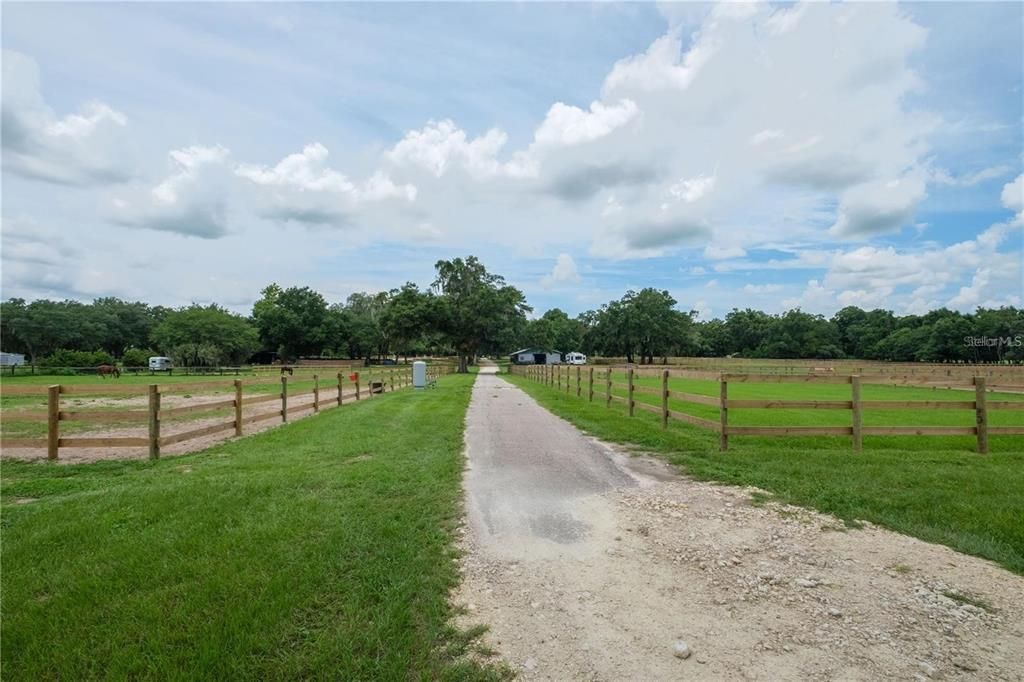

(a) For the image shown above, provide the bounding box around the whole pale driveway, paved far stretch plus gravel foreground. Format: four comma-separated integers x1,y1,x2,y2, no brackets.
455,371,1024,680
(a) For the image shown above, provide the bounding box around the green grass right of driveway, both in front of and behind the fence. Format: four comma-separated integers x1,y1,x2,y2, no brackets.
509,371,1024,573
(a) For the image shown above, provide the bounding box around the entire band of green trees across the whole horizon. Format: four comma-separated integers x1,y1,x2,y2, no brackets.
0,256,1024,371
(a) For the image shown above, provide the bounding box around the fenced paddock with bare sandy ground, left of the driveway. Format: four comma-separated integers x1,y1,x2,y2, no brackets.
0,361,450,461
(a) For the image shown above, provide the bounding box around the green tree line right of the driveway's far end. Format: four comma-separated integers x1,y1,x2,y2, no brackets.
522,289,1024,364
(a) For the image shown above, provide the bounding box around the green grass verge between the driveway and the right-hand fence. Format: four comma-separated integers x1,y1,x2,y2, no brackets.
508,375,1024,573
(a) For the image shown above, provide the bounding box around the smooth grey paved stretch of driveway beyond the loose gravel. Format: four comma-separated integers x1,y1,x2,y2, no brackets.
465,367,638,559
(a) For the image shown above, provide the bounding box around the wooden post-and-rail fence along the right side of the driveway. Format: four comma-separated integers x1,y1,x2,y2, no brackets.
511,365,1024,454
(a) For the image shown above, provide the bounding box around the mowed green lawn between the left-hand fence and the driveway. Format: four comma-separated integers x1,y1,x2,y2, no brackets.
0,376,500,680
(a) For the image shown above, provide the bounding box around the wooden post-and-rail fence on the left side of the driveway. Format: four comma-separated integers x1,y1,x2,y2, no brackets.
0,364,452,460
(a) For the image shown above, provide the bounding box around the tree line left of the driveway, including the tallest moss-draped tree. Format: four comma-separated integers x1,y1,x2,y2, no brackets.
0,256,530,371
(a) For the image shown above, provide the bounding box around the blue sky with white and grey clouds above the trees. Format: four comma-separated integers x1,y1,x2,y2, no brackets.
0,2,1024,319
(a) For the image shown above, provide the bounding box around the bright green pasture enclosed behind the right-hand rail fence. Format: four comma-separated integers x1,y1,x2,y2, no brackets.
514,360,1024,450
